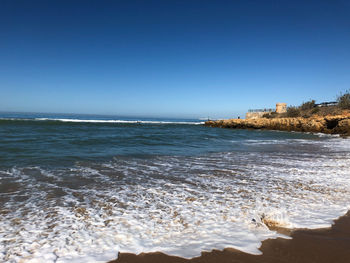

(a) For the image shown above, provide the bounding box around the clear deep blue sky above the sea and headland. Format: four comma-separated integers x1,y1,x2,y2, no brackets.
0,0,350,118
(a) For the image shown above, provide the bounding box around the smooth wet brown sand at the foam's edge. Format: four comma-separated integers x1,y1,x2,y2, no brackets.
110,211,350,263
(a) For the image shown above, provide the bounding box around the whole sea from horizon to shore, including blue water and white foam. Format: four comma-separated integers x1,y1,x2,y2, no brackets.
0,113,350,263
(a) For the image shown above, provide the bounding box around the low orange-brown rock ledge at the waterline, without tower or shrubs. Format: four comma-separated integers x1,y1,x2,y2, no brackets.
205,112,350,136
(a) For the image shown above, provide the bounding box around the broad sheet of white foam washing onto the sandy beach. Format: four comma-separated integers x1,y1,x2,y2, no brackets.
0,138,350,263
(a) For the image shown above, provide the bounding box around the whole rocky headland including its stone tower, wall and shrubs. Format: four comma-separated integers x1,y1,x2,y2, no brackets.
205,96,350,136
